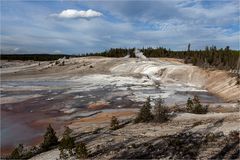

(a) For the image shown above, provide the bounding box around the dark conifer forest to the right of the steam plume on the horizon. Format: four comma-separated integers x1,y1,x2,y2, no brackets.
141,46,240,70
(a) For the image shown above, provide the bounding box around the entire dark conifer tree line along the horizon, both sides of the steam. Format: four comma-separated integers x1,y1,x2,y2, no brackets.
0,44,240,73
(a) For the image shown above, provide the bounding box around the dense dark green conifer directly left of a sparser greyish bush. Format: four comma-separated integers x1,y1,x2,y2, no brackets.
135,97,153,123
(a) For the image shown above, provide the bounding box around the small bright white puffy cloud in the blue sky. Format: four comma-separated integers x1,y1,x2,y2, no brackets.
51,9,103,19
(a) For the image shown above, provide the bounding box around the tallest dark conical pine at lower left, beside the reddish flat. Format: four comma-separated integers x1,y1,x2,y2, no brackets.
41,124,58,150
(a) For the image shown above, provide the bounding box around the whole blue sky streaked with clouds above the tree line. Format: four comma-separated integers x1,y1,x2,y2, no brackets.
1,0,240,54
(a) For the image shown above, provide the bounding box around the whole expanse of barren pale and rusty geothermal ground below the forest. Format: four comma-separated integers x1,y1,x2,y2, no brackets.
0,57,240,159
